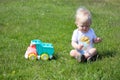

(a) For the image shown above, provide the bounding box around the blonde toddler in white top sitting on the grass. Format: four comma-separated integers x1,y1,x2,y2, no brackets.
70,8,101,62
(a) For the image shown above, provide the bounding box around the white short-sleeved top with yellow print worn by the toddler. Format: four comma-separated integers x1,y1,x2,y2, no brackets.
72,28,96,50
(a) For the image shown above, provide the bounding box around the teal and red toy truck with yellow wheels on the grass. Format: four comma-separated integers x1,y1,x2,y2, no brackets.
25,39,54,60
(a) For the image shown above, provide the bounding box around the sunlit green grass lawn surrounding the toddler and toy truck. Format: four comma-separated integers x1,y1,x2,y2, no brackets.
0,0,120,80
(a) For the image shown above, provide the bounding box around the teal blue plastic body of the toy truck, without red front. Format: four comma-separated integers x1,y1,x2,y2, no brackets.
31,39,54,59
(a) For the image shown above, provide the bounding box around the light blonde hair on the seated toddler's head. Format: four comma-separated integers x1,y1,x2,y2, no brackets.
75,7,92,25
